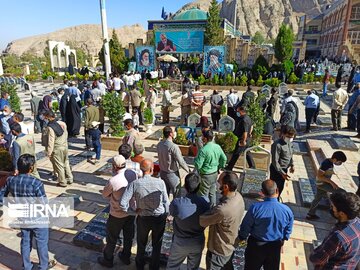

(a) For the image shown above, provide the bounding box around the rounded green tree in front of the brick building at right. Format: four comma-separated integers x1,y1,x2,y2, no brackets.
275,24,294,62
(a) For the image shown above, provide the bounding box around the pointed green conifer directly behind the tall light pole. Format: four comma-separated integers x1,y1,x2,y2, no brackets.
99,29,129,73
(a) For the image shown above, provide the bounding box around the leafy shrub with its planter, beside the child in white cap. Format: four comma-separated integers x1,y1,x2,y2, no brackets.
101,92,125,151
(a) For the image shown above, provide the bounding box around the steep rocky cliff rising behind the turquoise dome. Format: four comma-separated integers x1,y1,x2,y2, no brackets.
176,0,335,38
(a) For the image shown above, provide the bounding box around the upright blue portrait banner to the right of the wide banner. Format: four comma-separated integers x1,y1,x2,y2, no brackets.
204,46,225,76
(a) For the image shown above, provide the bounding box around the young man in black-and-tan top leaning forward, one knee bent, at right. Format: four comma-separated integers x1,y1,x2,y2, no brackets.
306,151,347,220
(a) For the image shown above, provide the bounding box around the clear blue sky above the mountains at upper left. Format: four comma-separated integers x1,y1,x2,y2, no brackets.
0,0,192,52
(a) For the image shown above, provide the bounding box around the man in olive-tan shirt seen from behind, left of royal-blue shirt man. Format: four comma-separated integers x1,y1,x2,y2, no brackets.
200,172,245,270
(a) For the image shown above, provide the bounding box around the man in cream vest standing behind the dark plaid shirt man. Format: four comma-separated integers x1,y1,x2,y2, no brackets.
10,123,40,179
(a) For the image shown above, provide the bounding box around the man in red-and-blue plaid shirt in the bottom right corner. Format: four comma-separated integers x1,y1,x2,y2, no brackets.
310,191,360,269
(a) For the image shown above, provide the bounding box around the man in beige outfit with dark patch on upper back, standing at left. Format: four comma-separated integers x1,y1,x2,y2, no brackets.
44,111,73,187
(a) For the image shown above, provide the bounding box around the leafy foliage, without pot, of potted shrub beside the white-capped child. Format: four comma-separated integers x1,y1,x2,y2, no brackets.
101,92,125,137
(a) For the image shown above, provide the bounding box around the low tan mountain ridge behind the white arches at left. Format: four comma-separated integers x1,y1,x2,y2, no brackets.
4,24,146,56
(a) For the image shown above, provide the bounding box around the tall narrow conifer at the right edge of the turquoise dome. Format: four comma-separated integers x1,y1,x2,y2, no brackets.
204,0,224,46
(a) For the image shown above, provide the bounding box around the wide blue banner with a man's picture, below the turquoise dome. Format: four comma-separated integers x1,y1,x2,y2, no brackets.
155,30,204,53
